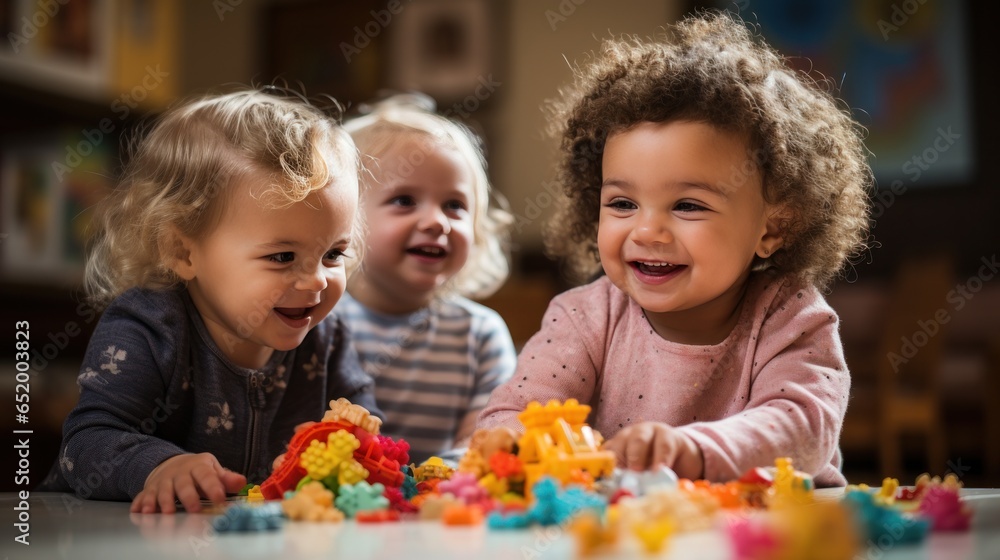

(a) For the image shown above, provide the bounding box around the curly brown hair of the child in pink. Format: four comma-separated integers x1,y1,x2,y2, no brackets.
545,12,872,287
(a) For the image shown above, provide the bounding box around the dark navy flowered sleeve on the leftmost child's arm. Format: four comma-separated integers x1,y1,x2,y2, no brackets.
59,294,185,500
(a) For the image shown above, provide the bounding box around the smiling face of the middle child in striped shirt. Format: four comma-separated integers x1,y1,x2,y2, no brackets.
351,134,475,313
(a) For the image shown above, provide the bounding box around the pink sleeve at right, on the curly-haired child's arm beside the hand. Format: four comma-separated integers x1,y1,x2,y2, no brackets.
679,288,850,486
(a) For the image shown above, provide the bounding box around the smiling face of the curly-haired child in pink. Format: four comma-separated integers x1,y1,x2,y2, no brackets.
598,121,781,344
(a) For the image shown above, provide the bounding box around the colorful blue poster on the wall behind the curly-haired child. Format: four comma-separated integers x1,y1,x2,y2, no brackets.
700,0,976,188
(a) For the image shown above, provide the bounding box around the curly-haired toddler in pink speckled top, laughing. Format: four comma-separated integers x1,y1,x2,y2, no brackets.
479,14,872,486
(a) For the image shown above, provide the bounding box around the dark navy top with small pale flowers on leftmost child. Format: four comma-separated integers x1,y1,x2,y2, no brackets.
39,288,381,500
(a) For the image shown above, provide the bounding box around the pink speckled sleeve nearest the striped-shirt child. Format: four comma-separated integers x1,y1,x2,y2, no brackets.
478,290,607,431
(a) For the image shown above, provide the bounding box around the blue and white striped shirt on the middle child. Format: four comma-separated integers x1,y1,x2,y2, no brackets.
336,294,517,464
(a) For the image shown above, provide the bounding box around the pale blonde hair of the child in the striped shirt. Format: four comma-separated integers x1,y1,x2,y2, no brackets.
344,93,514,298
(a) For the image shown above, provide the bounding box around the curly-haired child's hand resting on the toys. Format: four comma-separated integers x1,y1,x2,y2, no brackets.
603,422,705,480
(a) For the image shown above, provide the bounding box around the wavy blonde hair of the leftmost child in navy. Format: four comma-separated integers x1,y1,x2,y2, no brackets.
84,86,359,308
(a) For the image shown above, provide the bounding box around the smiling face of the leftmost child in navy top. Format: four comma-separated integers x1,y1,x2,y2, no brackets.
175,172,358,368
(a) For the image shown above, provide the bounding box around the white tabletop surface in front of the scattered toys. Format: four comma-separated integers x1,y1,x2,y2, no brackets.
0,489,1000,560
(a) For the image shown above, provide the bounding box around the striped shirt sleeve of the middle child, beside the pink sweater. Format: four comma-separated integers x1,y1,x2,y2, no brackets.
454,309,517,447
